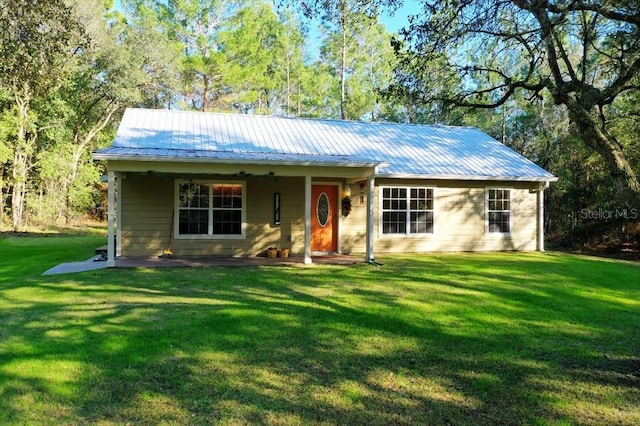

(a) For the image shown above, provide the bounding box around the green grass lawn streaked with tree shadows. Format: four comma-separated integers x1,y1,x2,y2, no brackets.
0,236,640,425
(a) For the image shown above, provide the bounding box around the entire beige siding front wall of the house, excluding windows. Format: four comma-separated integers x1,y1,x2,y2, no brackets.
119,173,537,256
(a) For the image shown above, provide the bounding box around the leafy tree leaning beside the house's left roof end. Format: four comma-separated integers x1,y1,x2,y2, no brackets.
45,0,178,224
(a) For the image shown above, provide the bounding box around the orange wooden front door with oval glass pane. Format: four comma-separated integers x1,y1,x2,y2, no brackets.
311,185,339,252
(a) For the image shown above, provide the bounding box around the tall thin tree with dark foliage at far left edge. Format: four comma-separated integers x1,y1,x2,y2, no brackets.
0,0,85,227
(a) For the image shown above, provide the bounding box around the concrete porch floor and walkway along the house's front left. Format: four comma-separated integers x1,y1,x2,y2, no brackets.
42,254,364,275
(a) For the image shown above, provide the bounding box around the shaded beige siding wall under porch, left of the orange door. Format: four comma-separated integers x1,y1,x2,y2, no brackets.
120,173,304,256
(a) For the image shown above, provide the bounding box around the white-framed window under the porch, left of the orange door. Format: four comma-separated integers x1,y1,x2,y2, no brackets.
178,182,244,237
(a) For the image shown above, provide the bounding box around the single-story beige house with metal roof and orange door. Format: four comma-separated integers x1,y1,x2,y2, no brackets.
94,109,557,266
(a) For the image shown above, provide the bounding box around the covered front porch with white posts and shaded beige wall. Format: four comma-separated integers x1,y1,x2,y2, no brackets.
107,160,378,267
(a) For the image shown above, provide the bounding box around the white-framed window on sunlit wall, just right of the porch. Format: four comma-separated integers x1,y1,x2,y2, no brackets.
381,187,433,235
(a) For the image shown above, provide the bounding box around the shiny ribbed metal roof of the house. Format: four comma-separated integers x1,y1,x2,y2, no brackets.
94,109,556,181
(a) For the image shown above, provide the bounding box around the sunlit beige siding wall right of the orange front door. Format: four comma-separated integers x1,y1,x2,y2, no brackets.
342,179,537,253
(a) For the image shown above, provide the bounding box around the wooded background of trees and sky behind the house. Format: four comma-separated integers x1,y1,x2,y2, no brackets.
0,0,640,249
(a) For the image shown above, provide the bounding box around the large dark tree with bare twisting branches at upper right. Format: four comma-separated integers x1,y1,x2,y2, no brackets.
401,0,640,195
